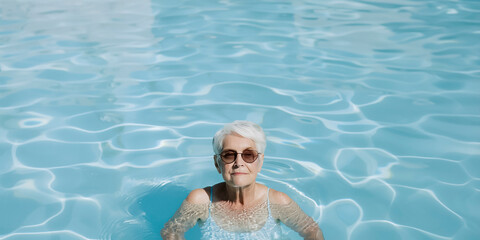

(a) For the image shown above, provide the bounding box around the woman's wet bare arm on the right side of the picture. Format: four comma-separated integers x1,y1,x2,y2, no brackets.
271,191,324,240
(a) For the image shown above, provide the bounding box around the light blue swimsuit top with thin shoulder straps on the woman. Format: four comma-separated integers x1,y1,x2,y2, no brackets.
200,187,282,240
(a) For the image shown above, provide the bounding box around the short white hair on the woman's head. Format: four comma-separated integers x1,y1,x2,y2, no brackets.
212,120,267,154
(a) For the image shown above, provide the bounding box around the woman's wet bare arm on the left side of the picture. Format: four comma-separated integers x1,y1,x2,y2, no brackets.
160,189,210,240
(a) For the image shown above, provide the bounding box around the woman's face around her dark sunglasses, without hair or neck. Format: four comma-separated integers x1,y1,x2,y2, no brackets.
214,134,263,187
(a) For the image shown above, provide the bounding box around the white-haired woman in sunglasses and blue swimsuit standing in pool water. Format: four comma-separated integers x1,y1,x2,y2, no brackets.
161,121,323,240
